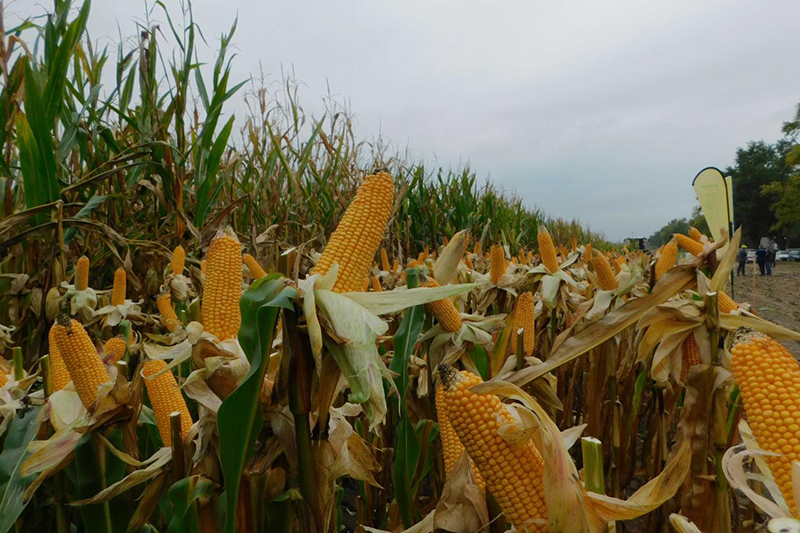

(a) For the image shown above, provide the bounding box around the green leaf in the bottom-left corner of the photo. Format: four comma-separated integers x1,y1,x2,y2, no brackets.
0,407,40,533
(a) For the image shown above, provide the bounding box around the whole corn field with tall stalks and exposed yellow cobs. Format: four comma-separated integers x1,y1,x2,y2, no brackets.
0,0,800,533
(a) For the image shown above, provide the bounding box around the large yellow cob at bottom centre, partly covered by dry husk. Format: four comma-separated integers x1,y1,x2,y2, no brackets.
439,365,547,532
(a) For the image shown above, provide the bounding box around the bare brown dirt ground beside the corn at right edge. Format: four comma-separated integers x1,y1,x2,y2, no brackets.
735,261,800,356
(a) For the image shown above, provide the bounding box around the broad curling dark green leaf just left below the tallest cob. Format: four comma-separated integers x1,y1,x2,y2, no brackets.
217,274,297,533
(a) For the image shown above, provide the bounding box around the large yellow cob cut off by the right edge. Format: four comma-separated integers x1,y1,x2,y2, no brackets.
731,330,800,517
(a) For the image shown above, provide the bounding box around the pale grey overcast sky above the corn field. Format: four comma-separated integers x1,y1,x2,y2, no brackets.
8,0,800,239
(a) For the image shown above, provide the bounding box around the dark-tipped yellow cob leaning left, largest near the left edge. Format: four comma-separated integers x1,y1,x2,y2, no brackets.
52,314,111,409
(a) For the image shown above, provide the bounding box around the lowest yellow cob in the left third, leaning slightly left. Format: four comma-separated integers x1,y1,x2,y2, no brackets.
142,359,192,446
